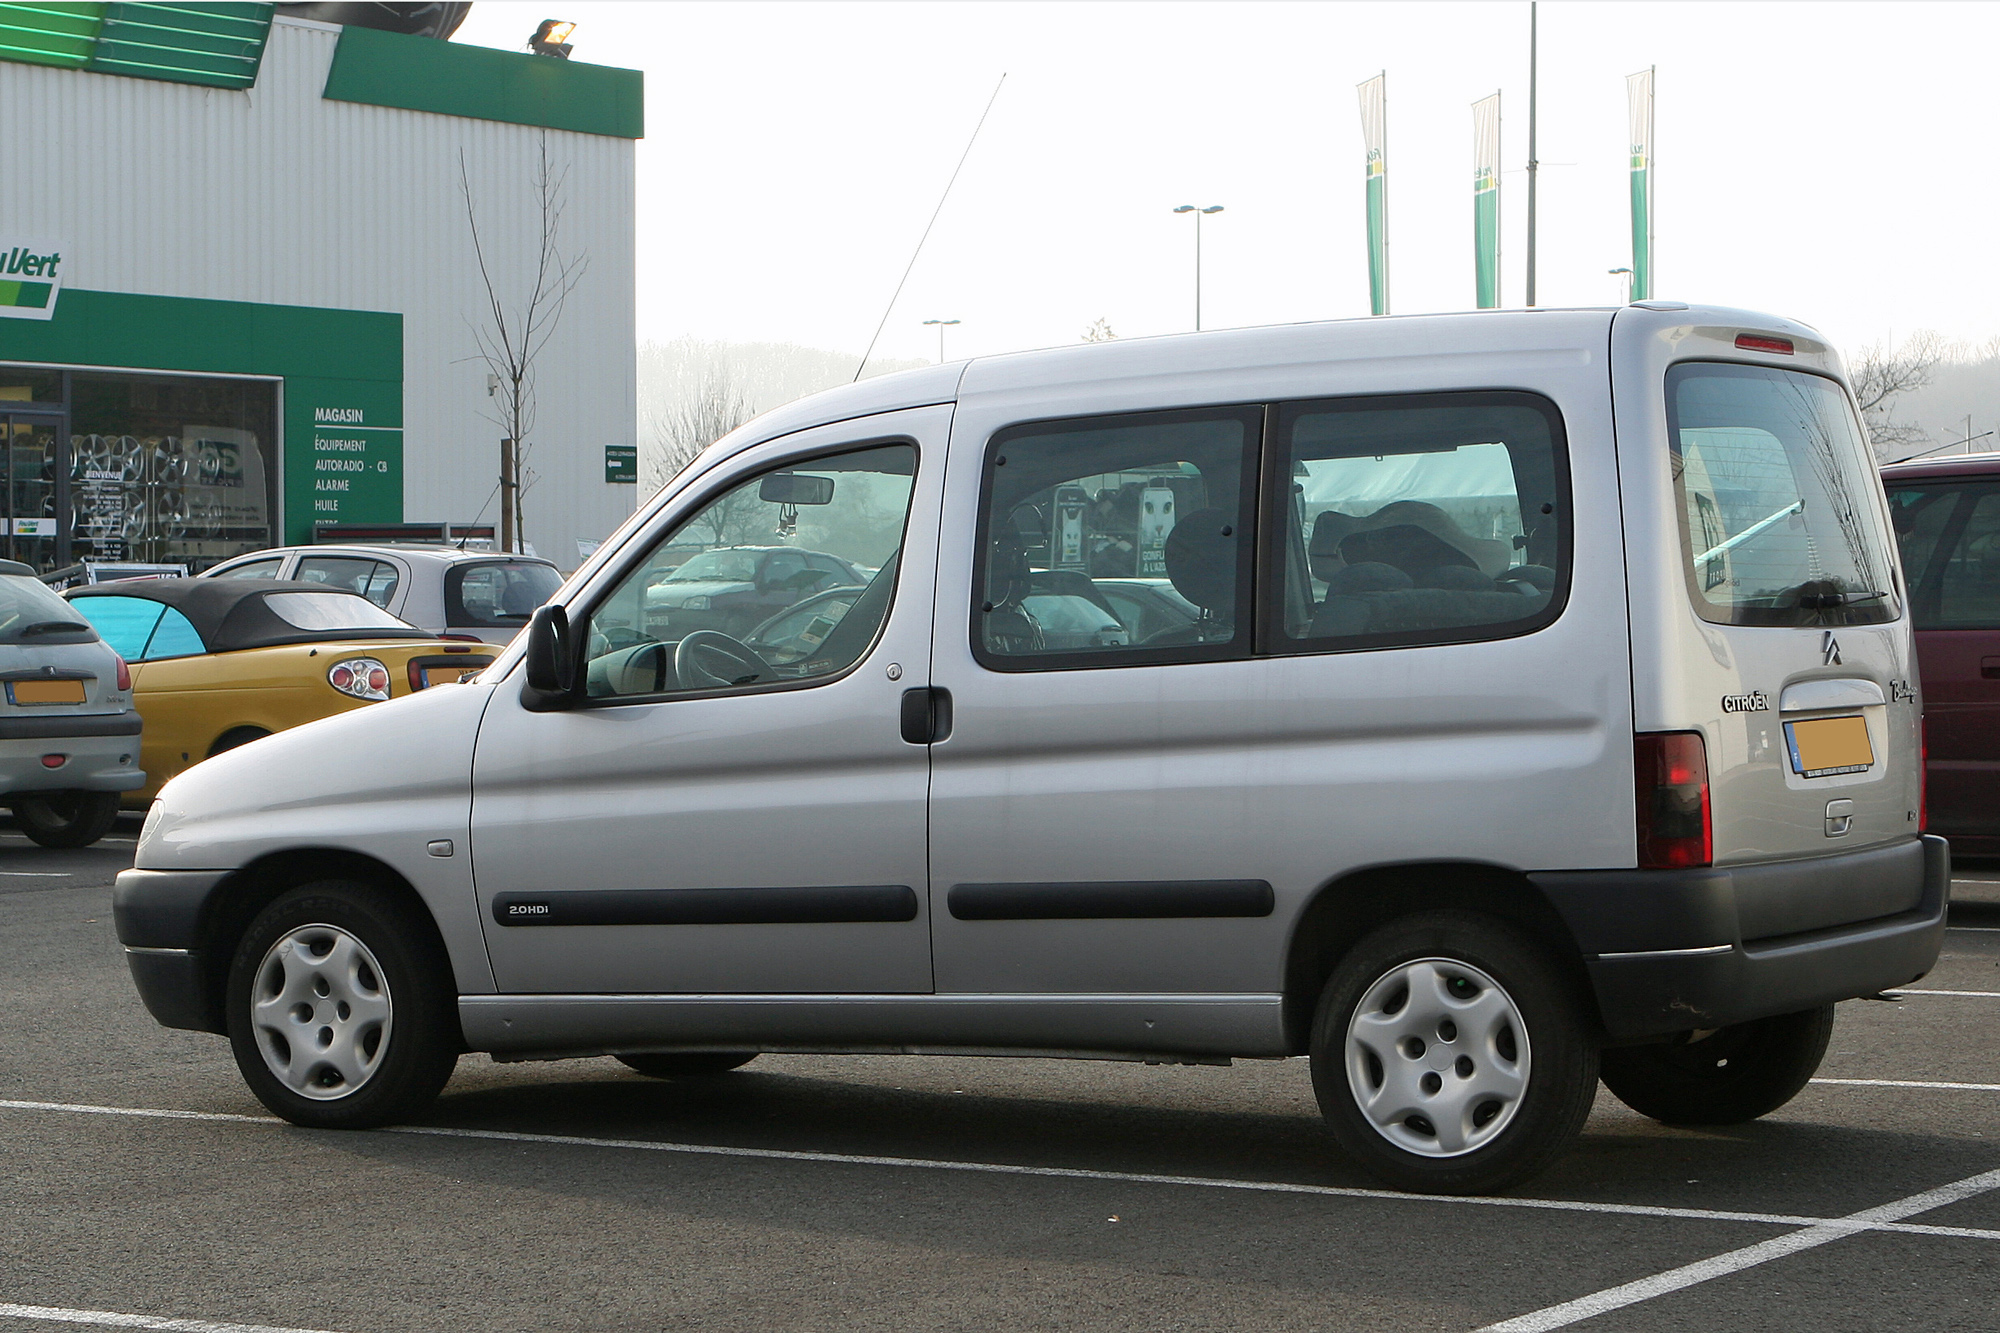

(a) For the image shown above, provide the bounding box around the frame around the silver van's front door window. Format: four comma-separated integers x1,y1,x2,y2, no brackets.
568,434,924,711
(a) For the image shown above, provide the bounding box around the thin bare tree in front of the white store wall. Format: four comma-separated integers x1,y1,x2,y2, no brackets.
458,134,590,550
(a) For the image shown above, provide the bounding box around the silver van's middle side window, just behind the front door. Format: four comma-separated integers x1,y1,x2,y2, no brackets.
972,408,1264,671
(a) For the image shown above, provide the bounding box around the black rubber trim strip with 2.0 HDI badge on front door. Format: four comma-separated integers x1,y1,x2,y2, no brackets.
492,885,918,927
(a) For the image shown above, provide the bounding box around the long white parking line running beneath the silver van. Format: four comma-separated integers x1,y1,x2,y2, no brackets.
0,1101,2000,1241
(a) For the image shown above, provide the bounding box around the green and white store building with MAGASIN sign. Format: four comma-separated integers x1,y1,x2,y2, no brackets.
0,0,642,568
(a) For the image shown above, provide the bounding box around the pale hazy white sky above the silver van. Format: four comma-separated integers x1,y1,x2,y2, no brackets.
458,0,2000,368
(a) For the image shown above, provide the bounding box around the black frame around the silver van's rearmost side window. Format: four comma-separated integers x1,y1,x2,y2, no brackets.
1258,388,1576,656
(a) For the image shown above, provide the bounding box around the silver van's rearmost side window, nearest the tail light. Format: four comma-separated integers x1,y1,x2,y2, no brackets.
1270,392,1568,650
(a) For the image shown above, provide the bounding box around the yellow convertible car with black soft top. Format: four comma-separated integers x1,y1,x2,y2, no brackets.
64,578,492,809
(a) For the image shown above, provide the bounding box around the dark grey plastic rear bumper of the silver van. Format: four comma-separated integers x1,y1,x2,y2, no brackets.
1530,837,1952,1041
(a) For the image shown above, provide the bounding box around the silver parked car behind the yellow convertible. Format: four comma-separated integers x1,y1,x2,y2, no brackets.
200,546,562,644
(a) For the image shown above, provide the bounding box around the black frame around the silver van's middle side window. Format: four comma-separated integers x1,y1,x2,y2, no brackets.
966,402,1270,675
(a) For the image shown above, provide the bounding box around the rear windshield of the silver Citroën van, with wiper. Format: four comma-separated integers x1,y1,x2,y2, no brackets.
1666,362,1900,626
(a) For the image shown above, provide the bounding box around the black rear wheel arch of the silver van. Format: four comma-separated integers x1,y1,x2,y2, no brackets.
1284,861,1602,1055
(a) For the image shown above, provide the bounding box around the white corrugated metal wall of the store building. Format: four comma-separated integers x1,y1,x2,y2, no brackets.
0,18,638,568
